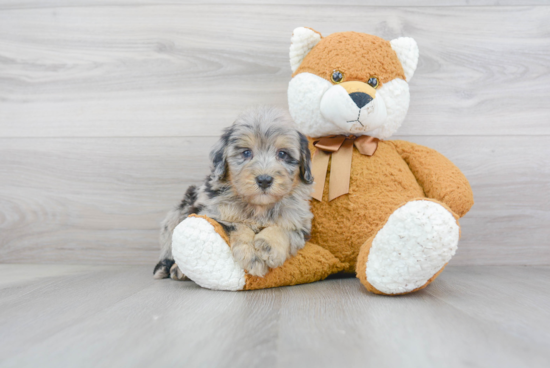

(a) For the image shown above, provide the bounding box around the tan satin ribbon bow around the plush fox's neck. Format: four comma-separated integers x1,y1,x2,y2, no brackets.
312,135,378,201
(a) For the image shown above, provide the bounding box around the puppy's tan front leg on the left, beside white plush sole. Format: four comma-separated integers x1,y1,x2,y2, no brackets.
229,224,268,276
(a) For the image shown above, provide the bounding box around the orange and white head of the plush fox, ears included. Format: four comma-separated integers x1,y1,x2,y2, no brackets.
288,27,418,139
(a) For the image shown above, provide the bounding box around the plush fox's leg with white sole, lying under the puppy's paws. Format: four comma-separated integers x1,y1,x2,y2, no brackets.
172,215,345,290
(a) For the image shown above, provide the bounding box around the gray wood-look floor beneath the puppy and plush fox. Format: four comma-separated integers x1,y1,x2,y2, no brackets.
0,265,550,367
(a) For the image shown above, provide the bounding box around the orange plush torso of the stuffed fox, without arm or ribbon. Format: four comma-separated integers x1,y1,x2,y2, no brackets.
310,140,436,272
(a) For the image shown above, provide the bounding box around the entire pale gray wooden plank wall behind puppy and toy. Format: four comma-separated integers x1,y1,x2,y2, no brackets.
0,0,550,265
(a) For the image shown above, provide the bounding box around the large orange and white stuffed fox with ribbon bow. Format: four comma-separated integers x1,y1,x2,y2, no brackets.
173,27,473,295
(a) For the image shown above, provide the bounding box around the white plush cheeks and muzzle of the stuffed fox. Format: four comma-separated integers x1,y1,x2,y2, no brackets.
288,73,410,139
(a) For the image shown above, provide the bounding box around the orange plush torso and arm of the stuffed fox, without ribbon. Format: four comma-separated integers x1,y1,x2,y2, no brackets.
310,140,473,272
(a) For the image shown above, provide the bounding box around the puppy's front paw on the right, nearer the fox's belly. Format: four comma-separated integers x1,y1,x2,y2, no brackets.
254,227,290,268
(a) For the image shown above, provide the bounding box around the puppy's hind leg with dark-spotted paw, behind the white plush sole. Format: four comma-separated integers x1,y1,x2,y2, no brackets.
153,209,186,280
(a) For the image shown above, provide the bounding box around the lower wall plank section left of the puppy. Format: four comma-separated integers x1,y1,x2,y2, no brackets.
0,138,214,263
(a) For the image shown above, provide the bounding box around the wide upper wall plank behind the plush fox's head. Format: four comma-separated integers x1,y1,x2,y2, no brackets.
0,3,550,137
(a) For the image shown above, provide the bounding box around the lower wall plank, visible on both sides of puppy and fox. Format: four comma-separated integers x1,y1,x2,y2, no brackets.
0,136,550,265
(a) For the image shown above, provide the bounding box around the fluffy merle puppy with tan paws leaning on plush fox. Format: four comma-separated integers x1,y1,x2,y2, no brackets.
154,107,313,280
